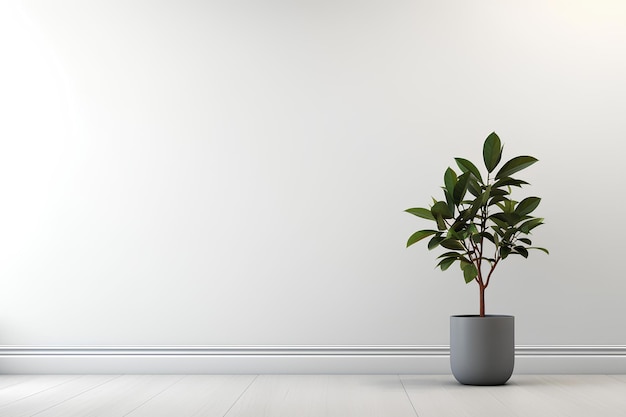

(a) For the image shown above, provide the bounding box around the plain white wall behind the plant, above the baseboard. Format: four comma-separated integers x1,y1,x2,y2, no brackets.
0,0,626,345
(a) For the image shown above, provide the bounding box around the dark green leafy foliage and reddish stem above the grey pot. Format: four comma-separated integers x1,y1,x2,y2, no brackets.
405,132,549,316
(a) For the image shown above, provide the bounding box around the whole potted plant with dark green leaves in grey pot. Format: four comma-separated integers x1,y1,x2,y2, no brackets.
406,132,548,385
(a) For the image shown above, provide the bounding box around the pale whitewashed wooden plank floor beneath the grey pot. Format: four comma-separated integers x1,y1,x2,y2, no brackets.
0,375,626,417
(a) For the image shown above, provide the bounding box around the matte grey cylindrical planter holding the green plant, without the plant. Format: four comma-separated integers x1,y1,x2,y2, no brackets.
450,315,515,385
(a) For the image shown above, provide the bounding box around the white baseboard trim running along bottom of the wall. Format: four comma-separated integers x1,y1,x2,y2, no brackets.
0,345,626,374
